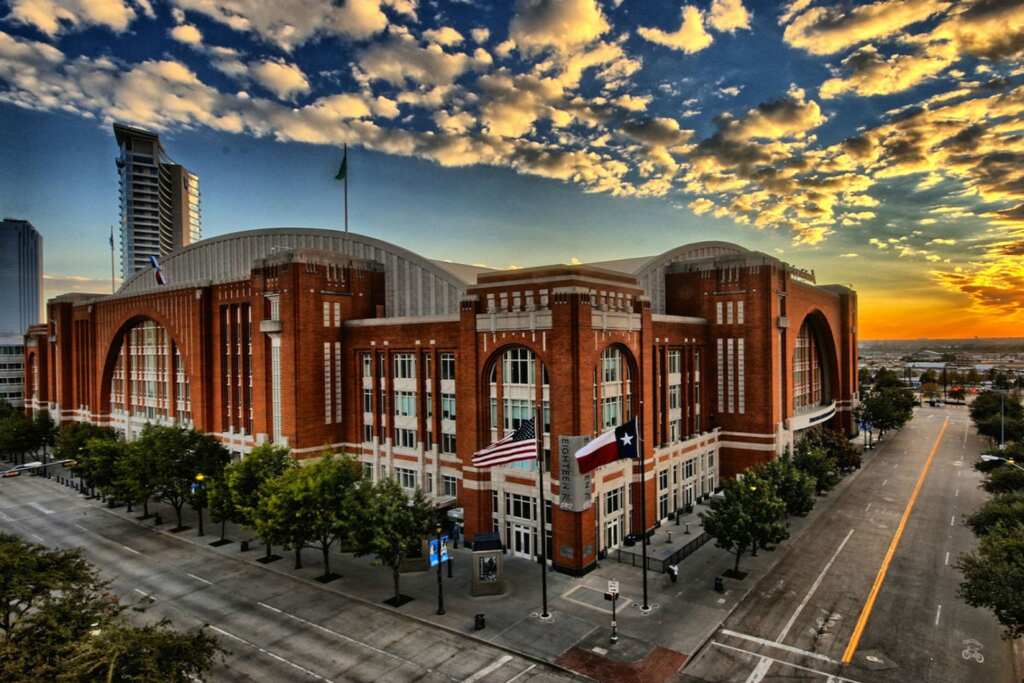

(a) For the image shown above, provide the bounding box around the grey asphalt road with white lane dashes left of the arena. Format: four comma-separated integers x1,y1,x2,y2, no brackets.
0,475,572,683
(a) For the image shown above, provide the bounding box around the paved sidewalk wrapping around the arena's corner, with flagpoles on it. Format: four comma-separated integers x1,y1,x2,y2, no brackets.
34,451,878,683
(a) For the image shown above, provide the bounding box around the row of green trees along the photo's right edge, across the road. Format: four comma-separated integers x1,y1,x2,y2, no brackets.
957,392,1024,638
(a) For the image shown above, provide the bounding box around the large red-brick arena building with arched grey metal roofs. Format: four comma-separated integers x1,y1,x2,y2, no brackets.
25,228,857,573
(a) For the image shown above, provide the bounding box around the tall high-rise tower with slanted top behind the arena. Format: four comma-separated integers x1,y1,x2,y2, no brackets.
114,123,202,281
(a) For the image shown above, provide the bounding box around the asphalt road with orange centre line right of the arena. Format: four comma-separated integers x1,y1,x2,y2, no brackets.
681,407,1014,683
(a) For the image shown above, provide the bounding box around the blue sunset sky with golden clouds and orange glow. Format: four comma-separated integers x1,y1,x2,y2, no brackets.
0,0,1024,338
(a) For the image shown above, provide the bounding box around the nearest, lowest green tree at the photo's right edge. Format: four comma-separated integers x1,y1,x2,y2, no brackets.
956,523,1024,639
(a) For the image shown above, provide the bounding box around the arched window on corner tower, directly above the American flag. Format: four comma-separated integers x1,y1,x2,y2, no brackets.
487,346,551,469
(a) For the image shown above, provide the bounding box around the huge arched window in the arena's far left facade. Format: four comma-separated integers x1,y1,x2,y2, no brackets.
111,321,191,425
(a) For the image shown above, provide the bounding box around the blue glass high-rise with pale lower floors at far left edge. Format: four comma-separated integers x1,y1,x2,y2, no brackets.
0,218,43,405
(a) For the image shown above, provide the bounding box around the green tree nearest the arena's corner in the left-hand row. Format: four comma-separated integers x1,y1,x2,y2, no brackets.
351,477,435,607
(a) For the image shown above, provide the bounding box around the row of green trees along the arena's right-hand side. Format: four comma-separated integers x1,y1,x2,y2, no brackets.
701,427,860,574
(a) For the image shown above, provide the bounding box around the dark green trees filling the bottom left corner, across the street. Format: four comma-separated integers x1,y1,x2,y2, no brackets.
0,533,223,683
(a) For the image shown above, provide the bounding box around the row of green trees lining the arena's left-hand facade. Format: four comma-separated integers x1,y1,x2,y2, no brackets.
54,422,439,601
